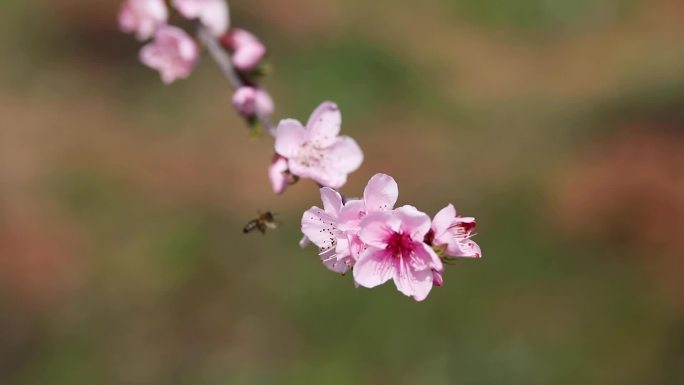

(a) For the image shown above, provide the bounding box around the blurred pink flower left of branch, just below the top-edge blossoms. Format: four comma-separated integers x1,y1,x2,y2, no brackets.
140,26,199,84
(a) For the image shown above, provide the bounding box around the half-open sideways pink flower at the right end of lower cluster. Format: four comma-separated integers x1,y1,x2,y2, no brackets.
428,204,482,258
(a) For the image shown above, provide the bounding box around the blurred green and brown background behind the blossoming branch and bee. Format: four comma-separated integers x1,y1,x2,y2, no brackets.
0,0,684,385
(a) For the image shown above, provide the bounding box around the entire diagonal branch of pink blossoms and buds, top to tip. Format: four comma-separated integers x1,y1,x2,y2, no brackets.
119,0,481,301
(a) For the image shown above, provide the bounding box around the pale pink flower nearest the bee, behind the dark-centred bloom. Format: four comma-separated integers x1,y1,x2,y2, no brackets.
302,174,399,273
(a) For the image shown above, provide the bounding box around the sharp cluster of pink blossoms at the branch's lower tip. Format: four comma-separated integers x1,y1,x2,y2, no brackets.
302,174,482,301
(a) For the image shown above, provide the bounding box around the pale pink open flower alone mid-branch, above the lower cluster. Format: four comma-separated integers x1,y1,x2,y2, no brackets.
275,102,363,188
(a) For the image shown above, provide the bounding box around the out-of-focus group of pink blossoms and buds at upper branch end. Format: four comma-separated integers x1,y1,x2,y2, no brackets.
119,0,274,118
